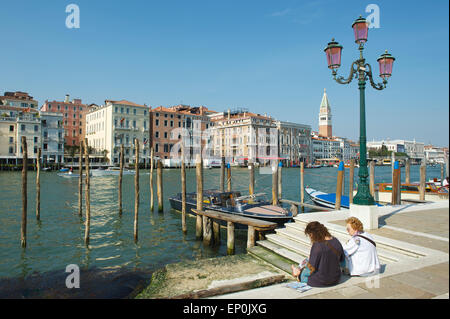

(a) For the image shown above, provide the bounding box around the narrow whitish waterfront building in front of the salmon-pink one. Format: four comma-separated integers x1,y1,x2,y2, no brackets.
40,112,64,164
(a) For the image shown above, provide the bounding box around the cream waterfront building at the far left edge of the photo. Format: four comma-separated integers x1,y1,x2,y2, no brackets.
0,91,42,164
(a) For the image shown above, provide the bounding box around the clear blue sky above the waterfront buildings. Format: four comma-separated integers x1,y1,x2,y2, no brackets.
0,0,449,146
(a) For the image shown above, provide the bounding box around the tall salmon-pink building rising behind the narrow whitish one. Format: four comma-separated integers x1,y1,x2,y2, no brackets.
41,94,94,146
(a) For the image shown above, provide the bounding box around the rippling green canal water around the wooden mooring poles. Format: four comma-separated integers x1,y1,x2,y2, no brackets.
0,166,440,298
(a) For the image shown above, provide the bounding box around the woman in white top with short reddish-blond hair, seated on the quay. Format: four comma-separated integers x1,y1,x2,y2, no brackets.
344,217,380,276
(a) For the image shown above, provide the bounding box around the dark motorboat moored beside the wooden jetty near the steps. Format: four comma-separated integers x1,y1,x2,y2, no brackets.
169,189,294,229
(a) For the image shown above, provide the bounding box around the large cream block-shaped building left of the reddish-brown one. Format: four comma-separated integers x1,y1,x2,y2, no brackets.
86,100,151,165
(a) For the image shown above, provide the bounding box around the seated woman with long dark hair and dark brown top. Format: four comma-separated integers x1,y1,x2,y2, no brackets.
292,222,344,287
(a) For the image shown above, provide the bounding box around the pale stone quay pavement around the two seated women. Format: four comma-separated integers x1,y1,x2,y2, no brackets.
212,201,449,299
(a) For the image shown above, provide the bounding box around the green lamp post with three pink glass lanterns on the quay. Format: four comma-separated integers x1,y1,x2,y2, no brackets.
324,16,395,205
